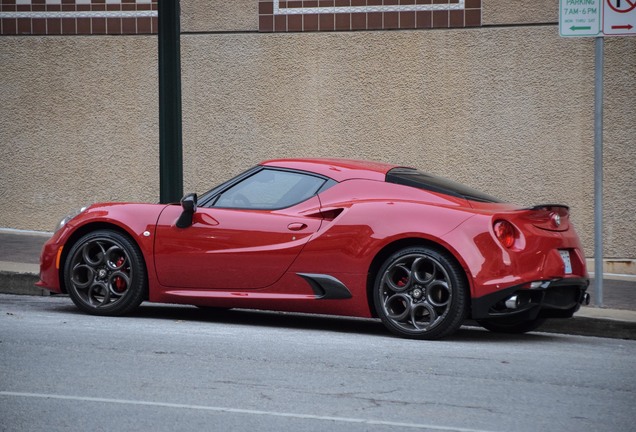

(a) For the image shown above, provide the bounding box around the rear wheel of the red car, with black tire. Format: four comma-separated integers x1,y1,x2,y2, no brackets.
373,247,469,340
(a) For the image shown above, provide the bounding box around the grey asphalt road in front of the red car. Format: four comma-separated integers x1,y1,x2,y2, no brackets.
0,295,636,432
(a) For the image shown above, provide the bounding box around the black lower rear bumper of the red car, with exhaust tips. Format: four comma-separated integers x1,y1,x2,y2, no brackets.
471,278,589,320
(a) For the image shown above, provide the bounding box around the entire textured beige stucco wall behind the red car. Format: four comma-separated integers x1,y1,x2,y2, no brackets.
0,0,636,258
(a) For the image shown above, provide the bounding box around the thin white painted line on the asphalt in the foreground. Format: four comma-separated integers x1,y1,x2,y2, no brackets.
0,391,492,432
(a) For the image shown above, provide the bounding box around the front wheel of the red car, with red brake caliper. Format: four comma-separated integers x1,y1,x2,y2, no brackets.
64,230,148,316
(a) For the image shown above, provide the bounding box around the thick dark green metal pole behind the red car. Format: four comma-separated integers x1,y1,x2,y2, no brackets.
159,0,183,203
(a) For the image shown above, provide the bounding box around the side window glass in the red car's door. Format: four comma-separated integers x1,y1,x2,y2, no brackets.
214,169,326,210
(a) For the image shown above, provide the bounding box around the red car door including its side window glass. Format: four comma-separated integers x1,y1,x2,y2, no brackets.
155,169,327,289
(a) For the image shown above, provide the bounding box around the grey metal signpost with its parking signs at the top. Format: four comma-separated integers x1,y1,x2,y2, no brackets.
559,0,636,307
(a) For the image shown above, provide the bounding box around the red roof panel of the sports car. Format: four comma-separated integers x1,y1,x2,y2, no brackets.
260,159,399,182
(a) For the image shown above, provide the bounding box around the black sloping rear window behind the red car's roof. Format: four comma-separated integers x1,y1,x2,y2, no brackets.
386,168,503,203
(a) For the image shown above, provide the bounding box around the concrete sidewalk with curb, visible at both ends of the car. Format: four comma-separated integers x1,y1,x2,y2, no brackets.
0,229,636,339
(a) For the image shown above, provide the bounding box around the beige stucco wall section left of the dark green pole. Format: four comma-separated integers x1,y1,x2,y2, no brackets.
0,36,159,231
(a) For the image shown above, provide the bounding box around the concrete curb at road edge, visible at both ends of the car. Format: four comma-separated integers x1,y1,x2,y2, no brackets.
0,271,636,340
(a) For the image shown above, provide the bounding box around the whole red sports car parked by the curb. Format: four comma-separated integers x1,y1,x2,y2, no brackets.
37,159,589,339
